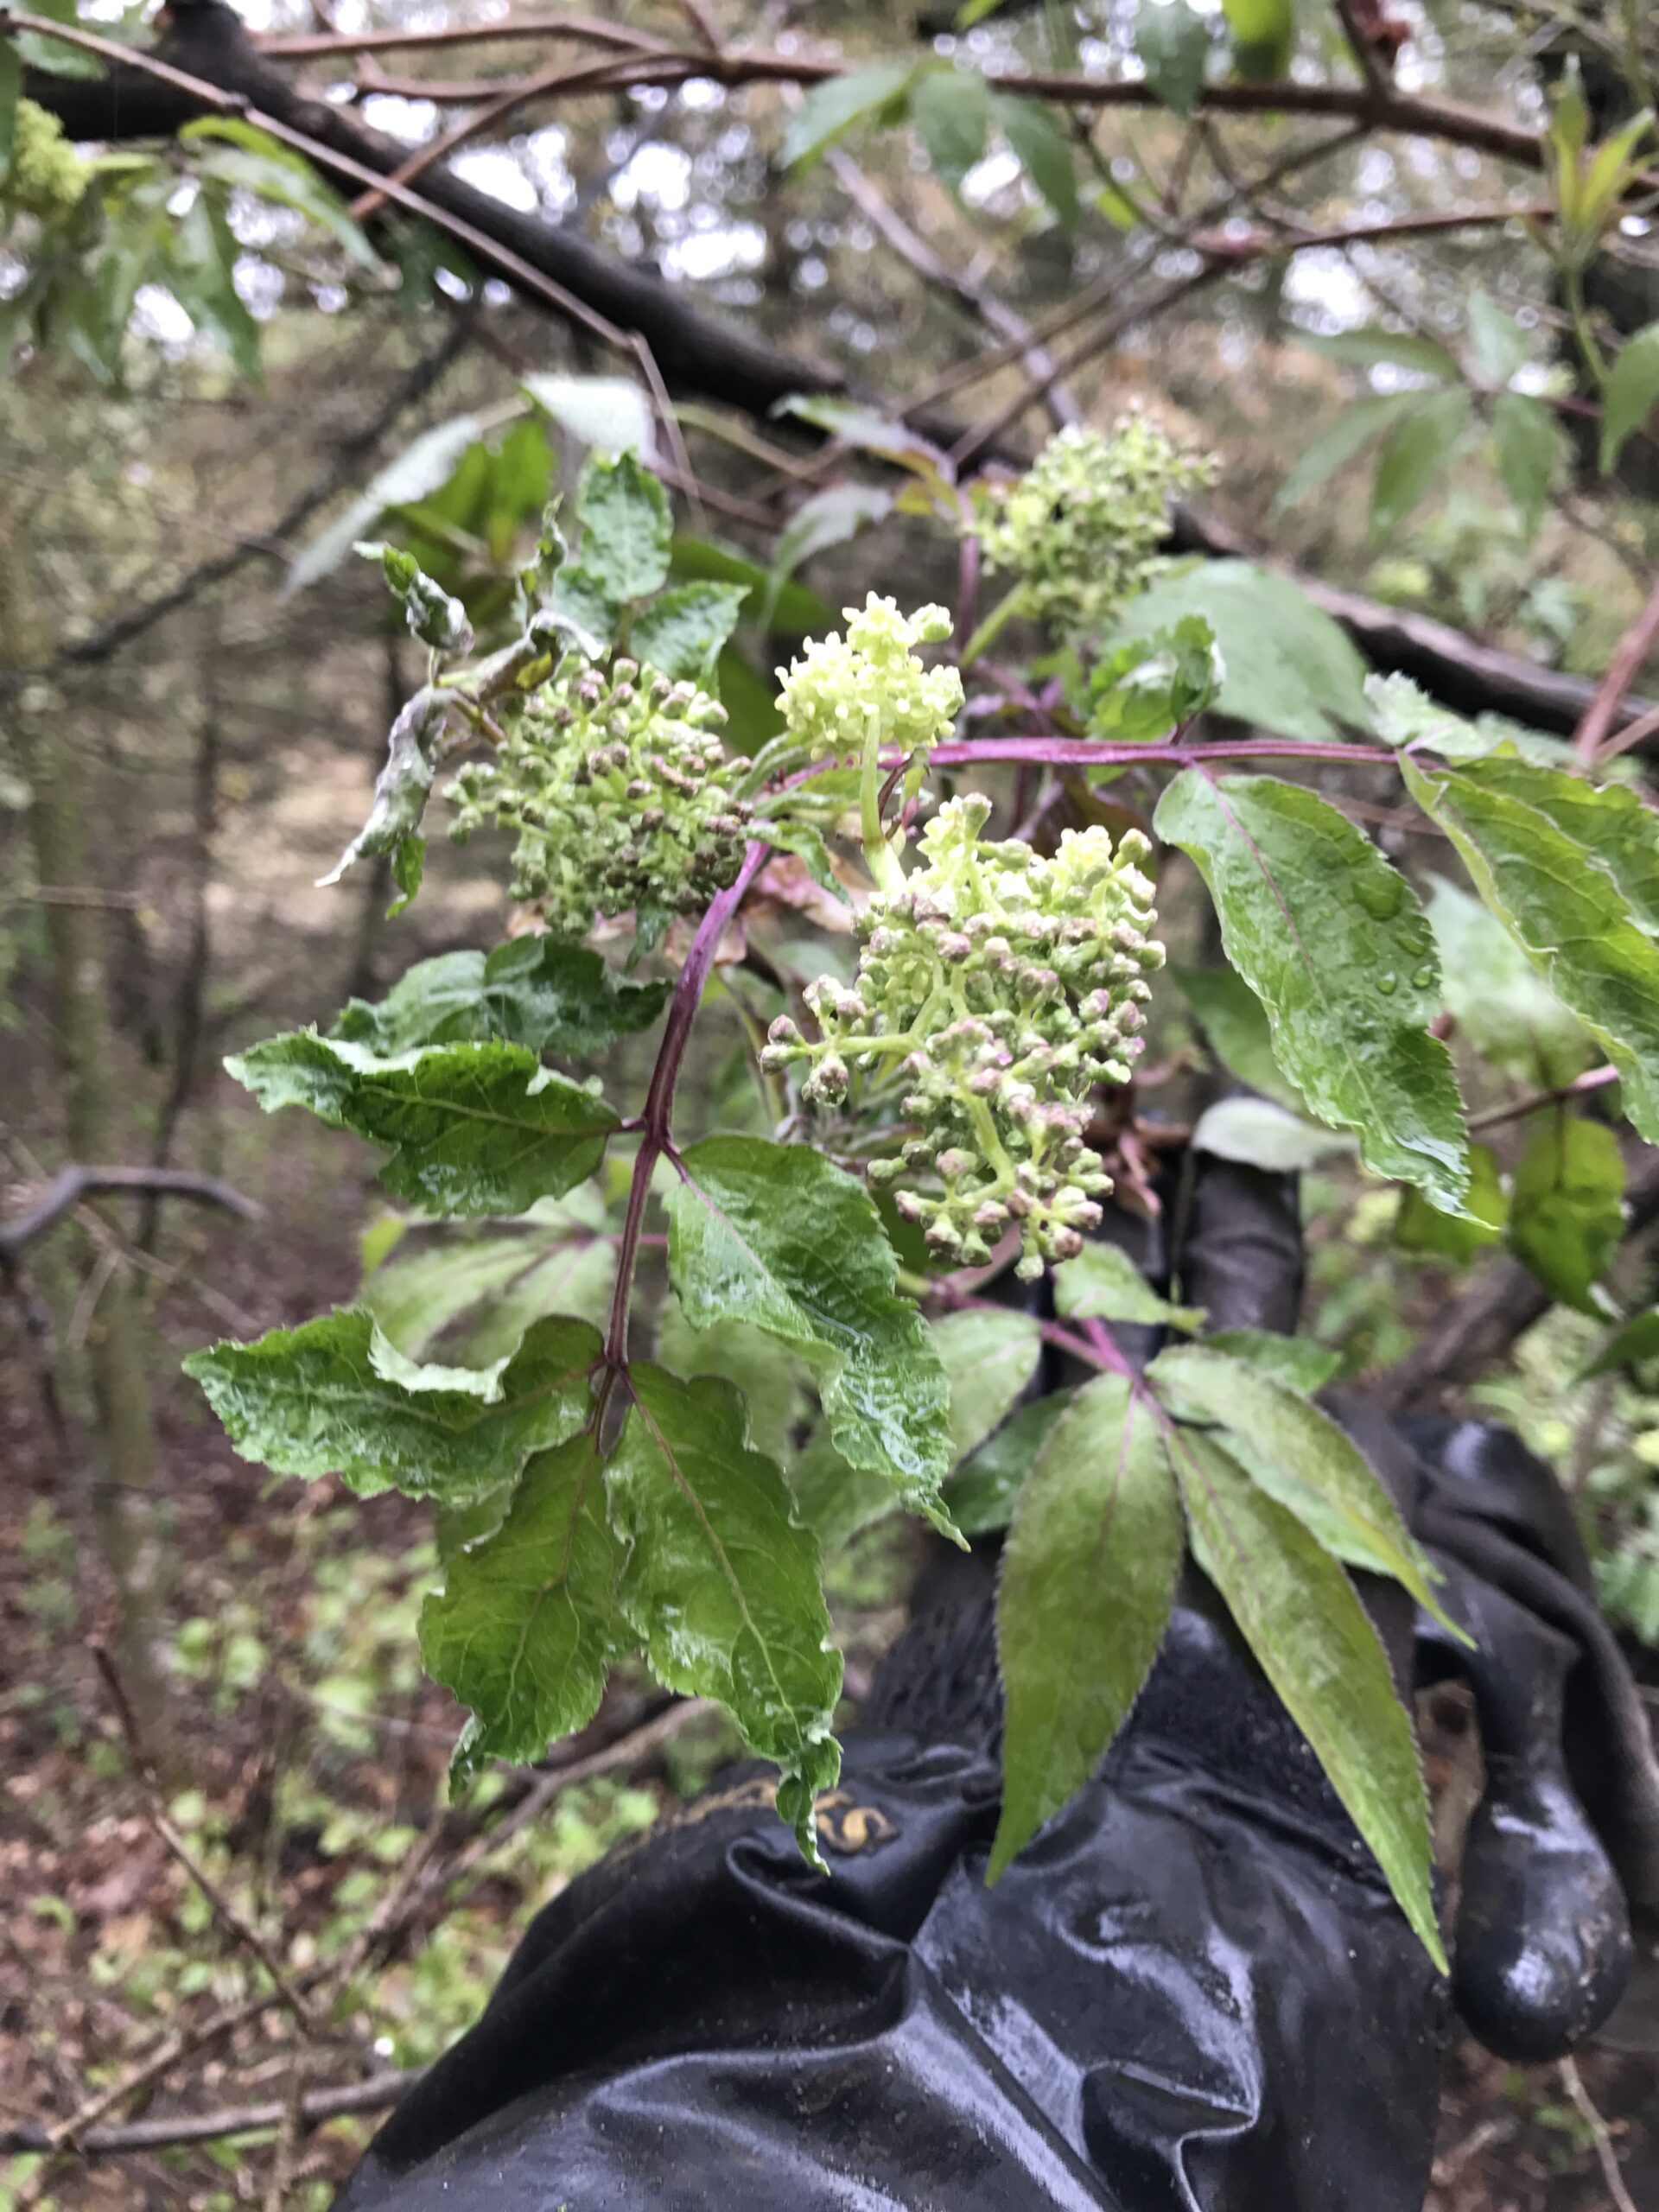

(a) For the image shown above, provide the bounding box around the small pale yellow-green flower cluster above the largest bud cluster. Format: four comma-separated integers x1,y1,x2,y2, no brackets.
779,591,963,752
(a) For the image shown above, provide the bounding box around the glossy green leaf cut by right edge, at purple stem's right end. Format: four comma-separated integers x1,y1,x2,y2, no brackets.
1402,759,1659,1144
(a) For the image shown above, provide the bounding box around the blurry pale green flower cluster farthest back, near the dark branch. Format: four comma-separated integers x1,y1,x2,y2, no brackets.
978,414,1214,637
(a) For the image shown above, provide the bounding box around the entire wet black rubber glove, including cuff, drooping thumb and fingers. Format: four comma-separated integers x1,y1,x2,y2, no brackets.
339,1161,1659,2212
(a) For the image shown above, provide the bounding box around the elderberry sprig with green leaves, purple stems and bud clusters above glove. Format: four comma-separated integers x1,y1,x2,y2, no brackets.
188,410,1659,1955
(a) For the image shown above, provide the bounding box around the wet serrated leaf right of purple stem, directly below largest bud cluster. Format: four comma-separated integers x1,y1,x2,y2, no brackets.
668,1137,953,1535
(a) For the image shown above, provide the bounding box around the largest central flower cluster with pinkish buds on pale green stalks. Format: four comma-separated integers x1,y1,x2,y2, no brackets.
763,797,1164,1281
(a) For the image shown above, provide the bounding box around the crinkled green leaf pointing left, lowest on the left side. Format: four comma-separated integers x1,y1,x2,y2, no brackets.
183,1307,601,1500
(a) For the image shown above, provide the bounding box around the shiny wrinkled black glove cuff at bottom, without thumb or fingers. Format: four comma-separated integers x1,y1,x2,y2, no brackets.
340,1606,1449,2212
